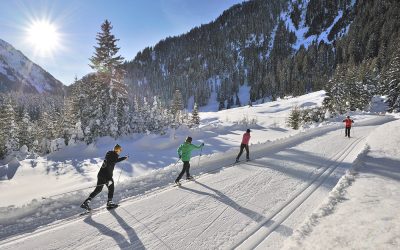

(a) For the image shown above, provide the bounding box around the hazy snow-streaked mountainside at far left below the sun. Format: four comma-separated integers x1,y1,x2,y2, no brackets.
0,39,63,94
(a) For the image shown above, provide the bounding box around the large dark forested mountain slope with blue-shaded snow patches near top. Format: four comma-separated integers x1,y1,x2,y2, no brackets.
126,0,400,109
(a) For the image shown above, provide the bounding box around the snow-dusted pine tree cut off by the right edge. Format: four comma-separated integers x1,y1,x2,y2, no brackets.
384,42,400,112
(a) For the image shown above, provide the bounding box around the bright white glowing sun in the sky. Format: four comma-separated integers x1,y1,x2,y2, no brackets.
27,20,61,57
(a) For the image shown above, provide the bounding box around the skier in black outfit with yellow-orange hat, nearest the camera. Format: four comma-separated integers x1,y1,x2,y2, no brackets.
81,144,128,210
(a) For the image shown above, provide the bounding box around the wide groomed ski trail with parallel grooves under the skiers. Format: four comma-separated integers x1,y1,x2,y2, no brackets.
0,116,392,249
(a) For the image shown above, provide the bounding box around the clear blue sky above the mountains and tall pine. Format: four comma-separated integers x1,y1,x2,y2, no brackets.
0,0,243,85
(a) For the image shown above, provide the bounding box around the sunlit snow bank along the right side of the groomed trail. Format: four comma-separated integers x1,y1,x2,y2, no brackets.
286,120,400,249
